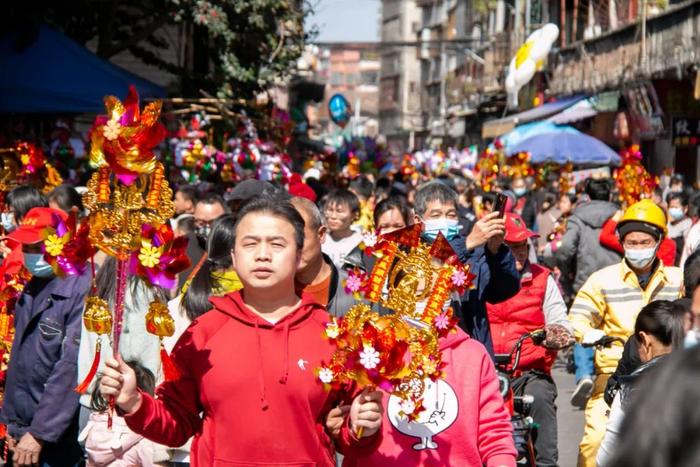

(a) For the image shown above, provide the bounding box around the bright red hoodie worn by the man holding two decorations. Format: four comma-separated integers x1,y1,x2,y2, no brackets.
125,292,381,467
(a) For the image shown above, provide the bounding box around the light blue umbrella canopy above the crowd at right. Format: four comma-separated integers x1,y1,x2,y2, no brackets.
510,128,621,165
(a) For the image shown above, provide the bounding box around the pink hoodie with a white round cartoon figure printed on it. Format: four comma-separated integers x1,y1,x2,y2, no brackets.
343,329,517,467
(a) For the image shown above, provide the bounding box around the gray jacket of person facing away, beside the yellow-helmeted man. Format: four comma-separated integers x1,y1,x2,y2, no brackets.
556,201,620,293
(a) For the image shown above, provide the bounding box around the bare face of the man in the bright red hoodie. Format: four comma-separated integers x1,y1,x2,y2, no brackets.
232,213,300,290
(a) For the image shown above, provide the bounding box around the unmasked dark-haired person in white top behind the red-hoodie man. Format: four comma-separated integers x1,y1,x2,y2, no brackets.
321,189,362,268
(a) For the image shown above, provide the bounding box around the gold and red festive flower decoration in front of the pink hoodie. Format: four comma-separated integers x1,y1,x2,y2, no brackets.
316,225,473,424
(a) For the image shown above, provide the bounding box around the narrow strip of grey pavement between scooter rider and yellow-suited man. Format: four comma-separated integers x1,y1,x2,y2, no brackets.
552,360,583,467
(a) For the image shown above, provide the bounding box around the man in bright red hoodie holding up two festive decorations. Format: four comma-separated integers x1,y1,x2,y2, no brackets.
100,198,382,467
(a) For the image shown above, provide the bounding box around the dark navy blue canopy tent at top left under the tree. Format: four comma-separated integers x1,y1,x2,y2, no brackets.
0,26,165,113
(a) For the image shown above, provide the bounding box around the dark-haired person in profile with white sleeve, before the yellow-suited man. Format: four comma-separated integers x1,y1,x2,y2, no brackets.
596,299,688,467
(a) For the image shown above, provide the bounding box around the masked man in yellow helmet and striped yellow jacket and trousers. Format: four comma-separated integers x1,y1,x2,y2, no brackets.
569,200,683,467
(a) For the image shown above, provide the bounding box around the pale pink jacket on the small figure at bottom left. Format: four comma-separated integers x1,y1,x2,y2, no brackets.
80,412,155,467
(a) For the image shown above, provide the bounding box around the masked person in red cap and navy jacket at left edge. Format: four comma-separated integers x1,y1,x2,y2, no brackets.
0,208,90,467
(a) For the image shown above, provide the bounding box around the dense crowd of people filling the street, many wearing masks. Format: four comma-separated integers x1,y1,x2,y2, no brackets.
0,166,700,467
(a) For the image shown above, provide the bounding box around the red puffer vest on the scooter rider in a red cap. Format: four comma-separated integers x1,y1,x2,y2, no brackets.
486,264,557,374
